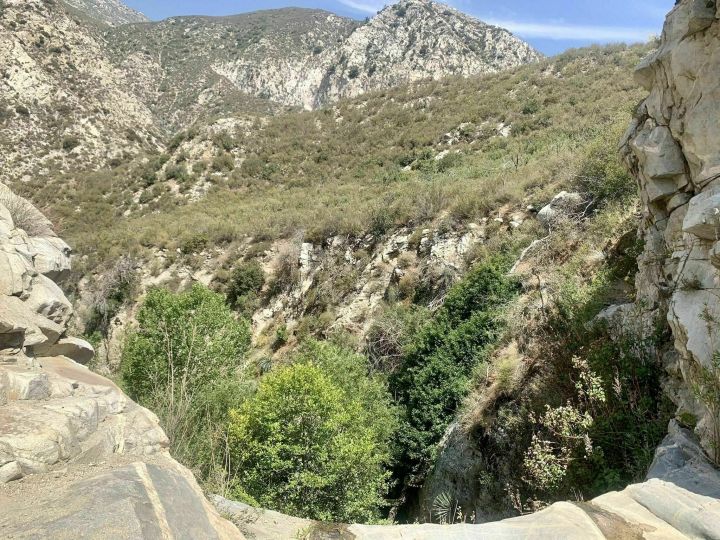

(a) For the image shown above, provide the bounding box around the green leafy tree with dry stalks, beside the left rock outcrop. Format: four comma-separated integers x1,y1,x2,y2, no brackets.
121,285,250,477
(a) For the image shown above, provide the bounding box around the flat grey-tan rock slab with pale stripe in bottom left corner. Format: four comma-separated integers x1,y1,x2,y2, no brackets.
0,460,243,540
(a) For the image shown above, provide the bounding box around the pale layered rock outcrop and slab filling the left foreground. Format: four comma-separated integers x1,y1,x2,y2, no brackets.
0,185,242,539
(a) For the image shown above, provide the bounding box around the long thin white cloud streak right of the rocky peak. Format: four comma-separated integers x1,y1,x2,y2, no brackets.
486,20,657,42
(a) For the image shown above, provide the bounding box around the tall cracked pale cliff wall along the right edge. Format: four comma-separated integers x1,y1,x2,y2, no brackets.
623,0,720,460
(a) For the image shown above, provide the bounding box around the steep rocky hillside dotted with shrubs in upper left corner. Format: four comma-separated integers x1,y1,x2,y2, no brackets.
0,0,160,183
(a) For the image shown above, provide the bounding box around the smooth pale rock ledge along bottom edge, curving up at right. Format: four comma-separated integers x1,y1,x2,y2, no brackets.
213,423,720,540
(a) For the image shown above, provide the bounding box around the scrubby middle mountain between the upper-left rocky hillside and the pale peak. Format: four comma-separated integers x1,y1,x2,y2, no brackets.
105,8,357,131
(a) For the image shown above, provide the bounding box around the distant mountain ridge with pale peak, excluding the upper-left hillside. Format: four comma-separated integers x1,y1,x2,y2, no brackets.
102,0,541,118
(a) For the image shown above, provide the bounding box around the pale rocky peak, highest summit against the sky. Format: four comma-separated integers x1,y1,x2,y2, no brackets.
316,0,542,105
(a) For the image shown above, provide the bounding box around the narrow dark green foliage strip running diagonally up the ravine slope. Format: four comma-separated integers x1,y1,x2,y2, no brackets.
390,262,518,485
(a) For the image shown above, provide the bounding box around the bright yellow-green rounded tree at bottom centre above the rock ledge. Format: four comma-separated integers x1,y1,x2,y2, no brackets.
229,342,395,522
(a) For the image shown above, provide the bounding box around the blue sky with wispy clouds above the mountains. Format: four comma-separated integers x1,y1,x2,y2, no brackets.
125,0,675,54
